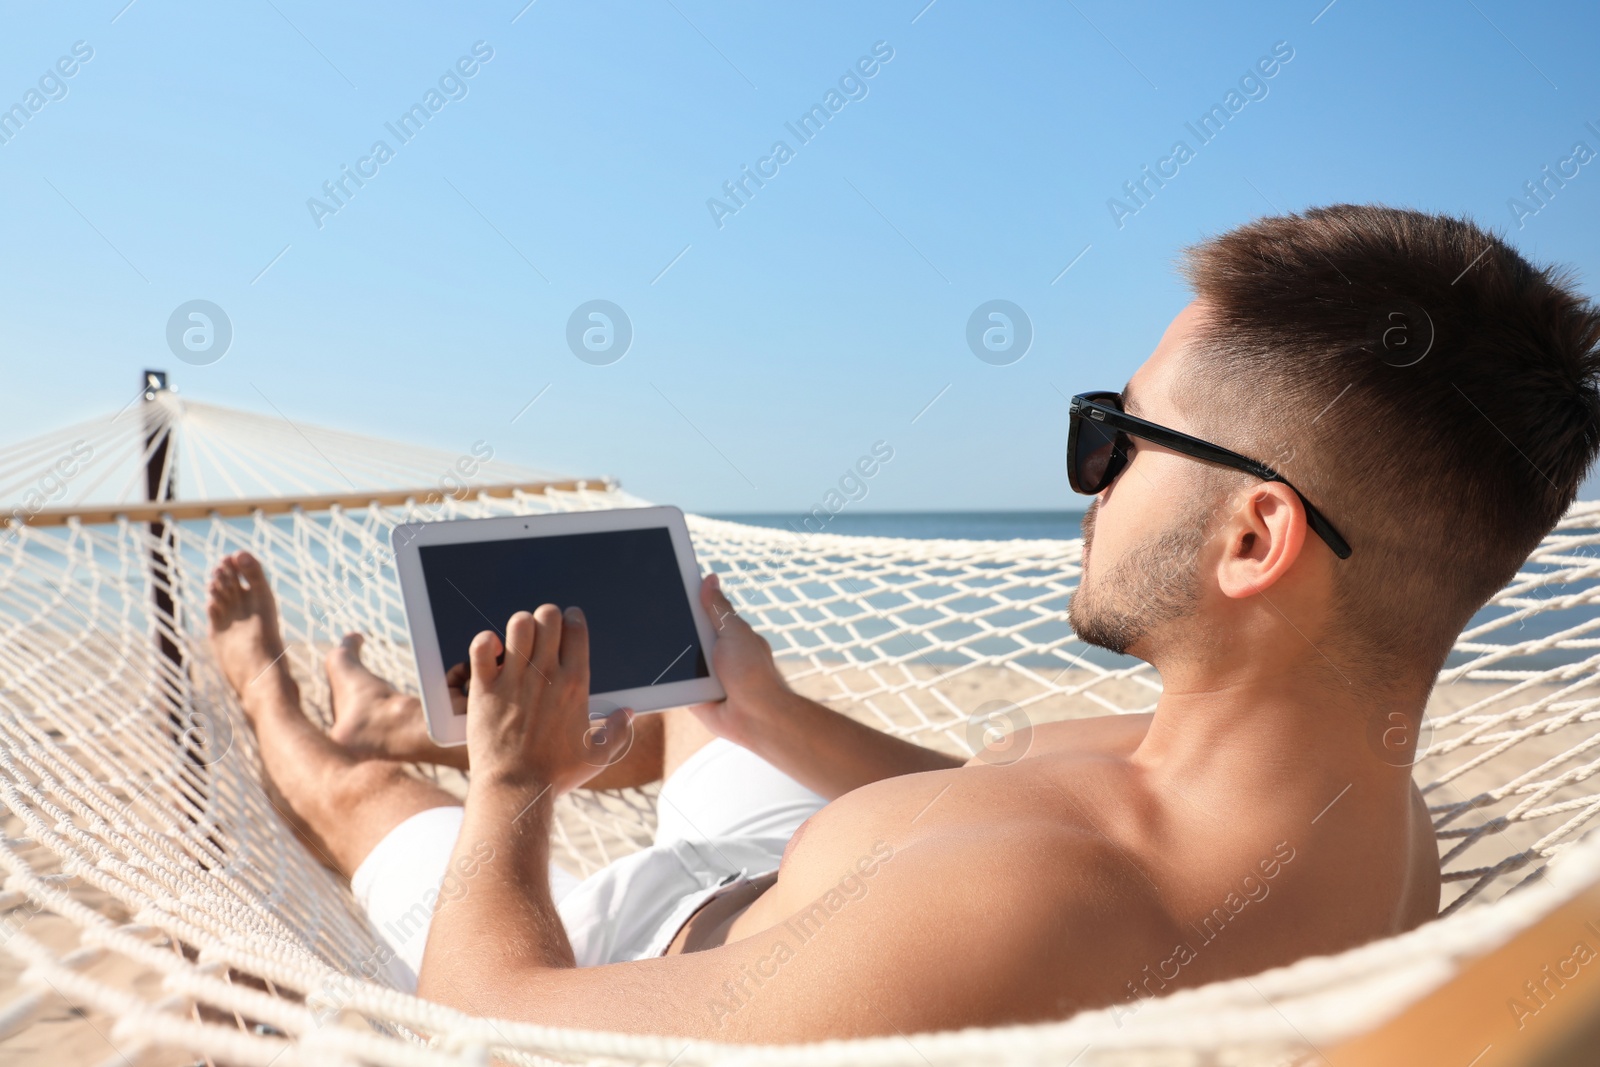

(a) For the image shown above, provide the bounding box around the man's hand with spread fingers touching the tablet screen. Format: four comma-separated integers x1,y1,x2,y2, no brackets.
467,605,634,797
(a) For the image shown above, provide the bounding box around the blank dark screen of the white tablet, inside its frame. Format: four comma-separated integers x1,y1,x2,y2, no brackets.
418,526,710,710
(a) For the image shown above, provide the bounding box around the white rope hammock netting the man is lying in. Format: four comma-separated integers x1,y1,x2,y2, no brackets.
0,392,1600,1067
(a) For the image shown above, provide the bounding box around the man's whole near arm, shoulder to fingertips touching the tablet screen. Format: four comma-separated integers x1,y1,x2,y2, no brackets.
406,605,1145,1041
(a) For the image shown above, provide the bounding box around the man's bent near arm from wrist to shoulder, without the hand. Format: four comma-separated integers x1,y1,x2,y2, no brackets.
418,781,1088,1043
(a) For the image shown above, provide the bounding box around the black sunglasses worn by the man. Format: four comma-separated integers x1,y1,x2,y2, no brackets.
1067,392,1350,560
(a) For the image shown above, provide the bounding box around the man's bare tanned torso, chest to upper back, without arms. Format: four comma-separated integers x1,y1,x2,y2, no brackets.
669,715,1438,1021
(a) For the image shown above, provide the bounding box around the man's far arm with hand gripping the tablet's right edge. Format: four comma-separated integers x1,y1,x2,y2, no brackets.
694,574,963,800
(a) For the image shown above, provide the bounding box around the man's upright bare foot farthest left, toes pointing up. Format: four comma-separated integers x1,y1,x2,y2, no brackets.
206,552,294,717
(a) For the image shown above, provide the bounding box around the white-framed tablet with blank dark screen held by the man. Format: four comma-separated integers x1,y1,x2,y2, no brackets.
390,507,725,745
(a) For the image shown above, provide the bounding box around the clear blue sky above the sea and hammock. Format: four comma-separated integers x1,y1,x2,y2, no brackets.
0,0,1600,510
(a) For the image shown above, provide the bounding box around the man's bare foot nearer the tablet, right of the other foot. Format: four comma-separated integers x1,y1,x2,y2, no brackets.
325,633,467,769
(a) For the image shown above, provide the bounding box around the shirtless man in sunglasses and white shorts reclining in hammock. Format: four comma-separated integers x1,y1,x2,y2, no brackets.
211,206,1600,1041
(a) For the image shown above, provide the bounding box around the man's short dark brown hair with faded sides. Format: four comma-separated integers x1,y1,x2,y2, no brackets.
1174,205,1600,667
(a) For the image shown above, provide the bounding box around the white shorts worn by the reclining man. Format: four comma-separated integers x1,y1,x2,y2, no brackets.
350,737,827,992
